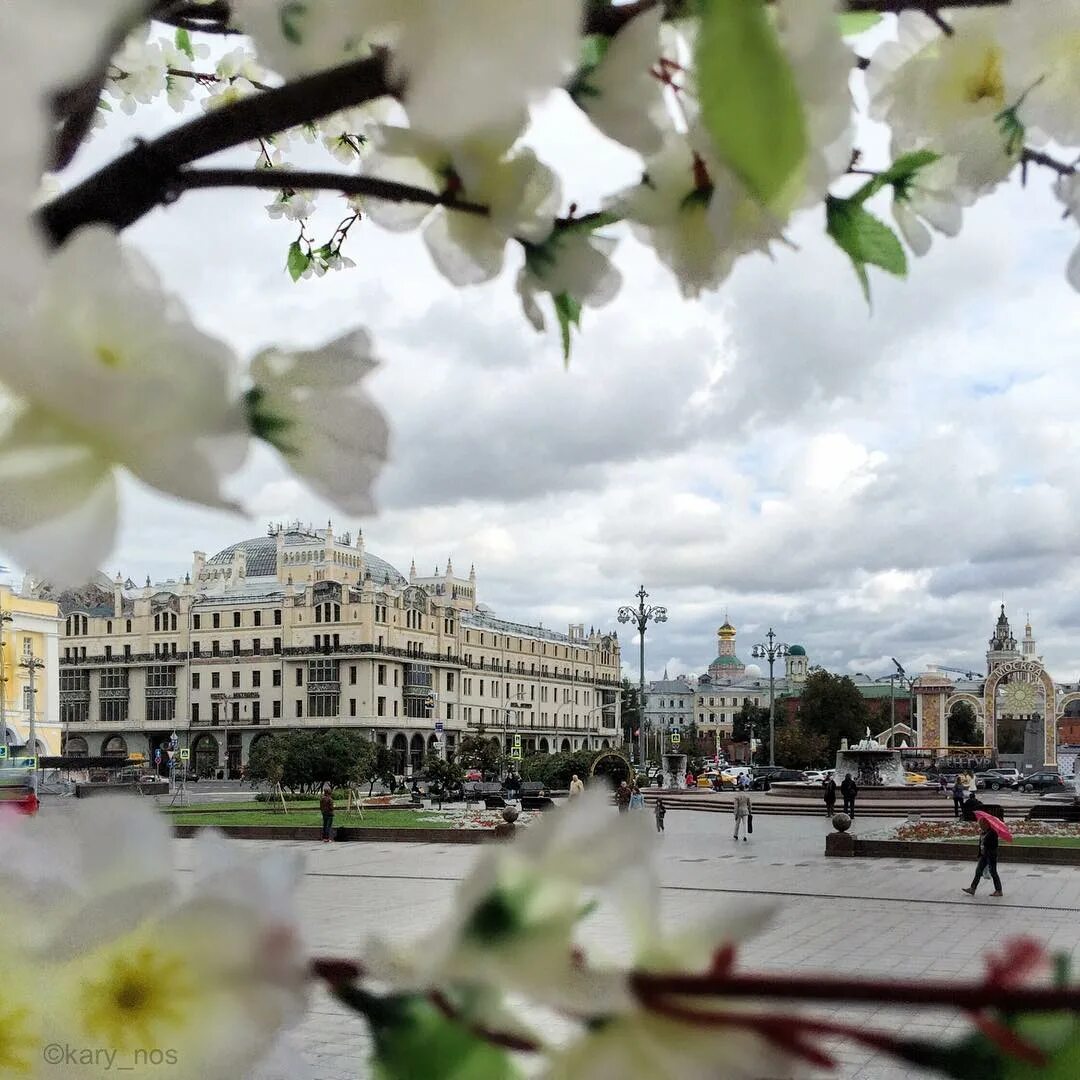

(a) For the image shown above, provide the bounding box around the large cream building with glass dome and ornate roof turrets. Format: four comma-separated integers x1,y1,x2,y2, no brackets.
35,523,621,777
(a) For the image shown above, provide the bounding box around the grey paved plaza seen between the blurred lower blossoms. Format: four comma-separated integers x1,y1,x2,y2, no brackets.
176,811,1080,1080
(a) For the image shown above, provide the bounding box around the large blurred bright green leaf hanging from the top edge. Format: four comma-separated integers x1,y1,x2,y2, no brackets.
694,0,807,206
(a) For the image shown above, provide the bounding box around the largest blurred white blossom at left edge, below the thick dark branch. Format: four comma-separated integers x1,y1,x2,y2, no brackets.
0,227,247,582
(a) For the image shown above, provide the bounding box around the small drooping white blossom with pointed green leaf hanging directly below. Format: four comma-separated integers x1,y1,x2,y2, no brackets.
516,221,622,330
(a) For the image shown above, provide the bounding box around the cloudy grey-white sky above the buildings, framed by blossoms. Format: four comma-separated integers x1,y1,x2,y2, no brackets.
12,16,1080,679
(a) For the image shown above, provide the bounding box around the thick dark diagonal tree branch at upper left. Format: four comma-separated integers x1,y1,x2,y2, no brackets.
39,54,392,245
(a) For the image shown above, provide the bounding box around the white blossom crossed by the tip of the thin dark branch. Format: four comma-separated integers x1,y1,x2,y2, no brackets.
364,123,562,285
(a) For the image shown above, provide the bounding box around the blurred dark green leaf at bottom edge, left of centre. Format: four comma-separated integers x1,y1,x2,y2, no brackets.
338,987,518,1080
